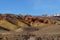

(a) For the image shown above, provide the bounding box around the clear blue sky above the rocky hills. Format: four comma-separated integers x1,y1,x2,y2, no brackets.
0,0,60,15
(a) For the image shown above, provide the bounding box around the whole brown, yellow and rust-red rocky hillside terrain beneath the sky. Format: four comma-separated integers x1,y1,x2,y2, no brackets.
0,14,60,40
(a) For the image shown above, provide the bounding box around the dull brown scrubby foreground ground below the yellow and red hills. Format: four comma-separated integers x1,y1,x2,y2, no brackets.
0,25,60,40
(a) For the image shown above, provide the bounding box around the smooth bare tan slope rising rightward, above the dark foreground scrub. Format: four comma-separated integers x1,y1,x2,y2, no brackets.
31,25,60,35
